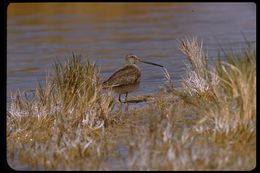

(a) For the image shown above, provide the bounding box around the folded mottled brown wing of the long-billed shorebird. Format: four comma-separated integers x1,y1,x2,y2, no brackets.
103,65,141,87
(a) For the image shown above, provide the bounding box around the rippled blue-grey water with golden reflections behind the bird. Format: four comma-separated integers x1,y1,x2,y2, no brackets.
7,3,256,107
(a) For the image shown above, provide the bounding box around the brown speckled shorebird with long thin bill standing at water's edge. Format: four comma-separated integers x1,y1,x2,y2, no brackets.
103,54,163,103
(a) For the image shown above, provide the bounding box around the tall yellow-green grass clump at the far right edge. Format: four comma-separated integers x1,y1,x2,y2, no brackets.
202,44,256,132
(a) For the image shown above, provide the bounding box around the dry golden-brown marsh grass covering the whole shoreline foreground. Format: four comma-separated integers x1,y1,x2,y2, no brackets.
7,38,256,170
